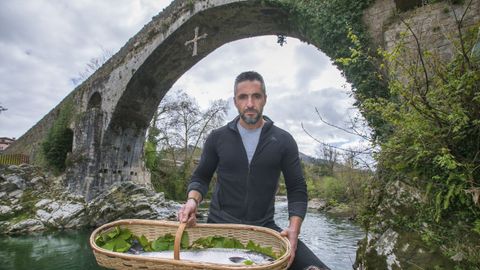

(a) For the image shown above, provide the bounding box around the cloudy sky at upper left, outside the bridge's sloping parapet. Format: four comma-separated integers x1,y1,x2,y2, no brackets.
0,0,170,137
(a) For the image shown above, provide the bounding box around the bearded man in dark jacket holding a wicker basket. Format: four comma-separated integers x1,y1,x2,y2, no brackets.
178,71,328,270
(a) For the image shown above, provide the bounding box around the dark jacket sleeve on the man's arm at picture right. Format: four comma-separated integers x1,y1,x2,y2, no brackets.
282,135,308,219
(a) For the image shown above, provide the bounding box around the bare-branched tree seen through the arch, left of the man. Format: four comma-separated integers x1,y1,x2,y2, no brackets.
145,91,227,198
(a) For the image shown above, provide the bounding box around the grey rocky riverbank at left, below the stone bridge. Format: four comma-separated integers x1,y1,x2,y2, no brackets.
0,164,180,234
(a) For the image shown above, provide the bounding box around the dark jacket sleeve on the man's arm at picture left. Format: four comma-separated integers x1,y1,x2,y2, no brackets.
187,131,218,198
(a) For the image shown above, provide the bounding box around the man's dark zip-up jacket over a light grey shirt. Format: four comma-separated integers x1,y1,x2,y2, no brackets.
188,116,307,226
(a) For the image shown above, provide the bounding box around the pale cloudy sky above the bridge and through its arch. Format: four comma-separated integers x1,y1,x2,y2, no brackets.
0,0,372,159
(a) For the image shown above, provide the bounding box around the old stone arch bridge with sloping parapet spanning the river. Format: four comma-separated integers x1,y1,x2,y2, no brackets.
8,0,480,200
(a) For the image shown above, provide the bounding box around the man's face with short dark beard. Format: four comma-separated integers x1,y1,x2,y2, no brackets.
234,81,267,125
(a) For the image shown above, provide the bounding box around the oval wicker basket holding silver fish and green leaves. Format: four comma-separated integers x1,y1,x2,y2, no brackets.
90,219,291,270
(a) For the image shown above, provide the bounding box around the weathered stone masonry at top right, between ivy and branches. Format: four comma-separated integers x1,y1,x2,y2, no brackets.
364,0,480,59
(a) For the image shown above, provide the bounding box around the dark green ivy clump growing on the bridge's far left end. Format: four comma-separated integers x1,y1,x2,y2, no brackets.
42,100,73,174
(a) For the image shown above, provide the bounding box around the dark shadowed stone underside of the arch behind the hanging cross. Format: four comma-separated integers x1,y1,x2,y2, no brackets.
107,2,305,134
